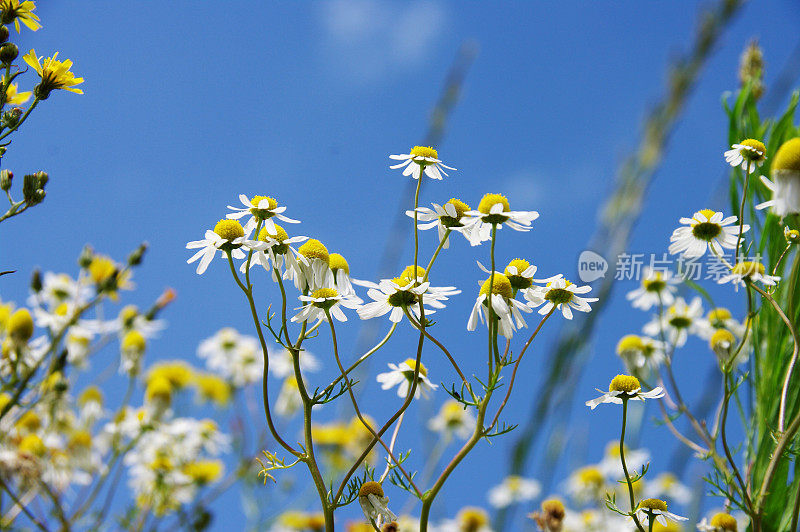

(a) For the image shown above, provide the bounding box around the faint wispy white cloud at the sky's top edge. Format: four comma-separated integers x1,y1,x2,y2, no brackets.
319,0,445,85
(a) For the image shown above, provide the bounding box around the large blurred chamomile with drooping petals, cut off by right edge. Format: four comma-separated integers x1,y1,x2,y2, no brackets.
756,137,800,216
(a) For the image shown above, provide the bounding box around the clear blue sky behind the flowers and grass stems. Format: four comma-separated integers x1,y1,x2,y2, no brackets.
0,0,800,530
